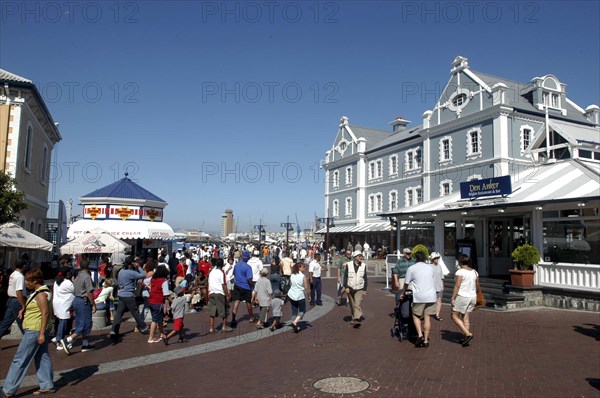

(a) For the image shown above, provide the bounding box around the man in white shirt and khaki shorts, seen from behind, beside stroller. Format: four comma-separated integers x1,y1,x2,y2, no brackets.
400,252,437,347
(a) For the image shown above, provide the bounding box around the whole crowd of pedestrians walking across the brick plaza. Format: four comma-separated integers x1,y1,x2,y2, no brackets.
0,244,480,396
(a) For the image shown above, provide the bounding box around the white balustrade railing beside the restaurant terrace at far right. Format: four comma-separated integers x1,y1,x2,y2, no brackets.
534,263,600,290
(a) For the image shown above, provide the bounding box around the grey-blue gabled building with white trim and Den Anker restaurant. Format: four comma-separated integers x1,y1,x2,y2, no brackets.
319,57,600,289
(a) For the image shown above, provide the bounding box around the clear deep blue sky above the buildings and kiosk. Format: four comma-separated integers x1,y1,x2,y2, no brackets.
0,1,600,233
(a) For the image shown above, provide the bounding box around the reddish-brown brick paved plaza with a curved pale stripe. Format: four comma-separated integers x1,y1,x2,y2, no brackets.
0,278,600,397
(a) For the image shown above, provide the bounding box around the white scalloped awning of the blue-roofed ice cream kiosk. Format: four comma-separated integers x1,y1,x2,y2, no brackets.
67,220,175,240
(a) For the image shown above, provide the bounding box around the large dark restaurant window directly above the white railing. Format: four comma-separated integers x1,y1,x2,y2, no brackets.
543,213,600,264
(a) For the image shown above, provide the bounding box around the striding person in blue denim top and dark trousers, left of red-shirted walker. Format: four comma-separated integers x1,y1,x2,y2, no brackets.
110,256,150,344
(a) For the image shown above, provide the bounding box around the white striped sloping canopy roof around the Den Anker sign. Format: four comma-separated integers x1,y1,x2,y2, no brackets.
381,159,600,217
